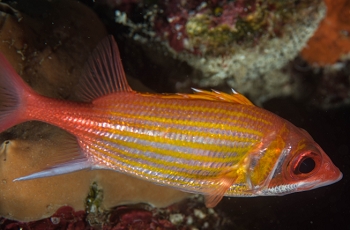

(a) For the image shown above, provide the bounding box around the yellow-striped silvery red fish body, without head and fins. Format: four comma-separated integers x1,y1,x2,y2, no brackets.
26,93,281,191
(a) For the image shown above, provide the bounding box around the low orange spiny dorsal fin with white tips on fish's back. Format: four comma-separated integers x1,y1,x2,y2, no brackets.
161,88,254,105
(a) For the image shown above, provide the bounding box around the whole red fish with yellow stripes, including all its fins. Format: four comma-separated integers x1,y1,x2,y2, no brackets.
0,36,342,207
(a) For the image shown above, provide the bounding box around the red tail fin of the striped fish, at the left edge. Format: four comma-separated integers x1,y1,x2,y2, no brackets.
0,53,35,132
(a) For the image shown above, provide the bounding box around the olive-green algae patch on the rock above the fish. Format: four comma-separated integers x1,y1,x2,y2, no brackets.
186,0,313,55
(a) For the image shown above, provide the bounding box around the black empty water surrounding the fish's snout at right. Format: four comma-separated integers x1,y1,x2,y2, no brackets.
218,98,350,230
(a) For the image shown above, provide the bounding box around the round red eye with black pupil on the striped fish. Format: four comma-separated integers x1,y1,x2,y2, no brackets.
290,151,322,179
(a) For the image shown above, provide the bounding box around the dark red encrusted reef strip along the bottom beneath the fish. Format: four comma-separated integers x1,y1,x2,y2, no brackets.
0,196,231,230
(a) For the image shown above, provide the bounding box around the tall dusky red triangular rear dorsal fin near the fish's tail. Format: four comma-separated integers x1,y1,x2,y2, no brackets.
76,36,132,102
